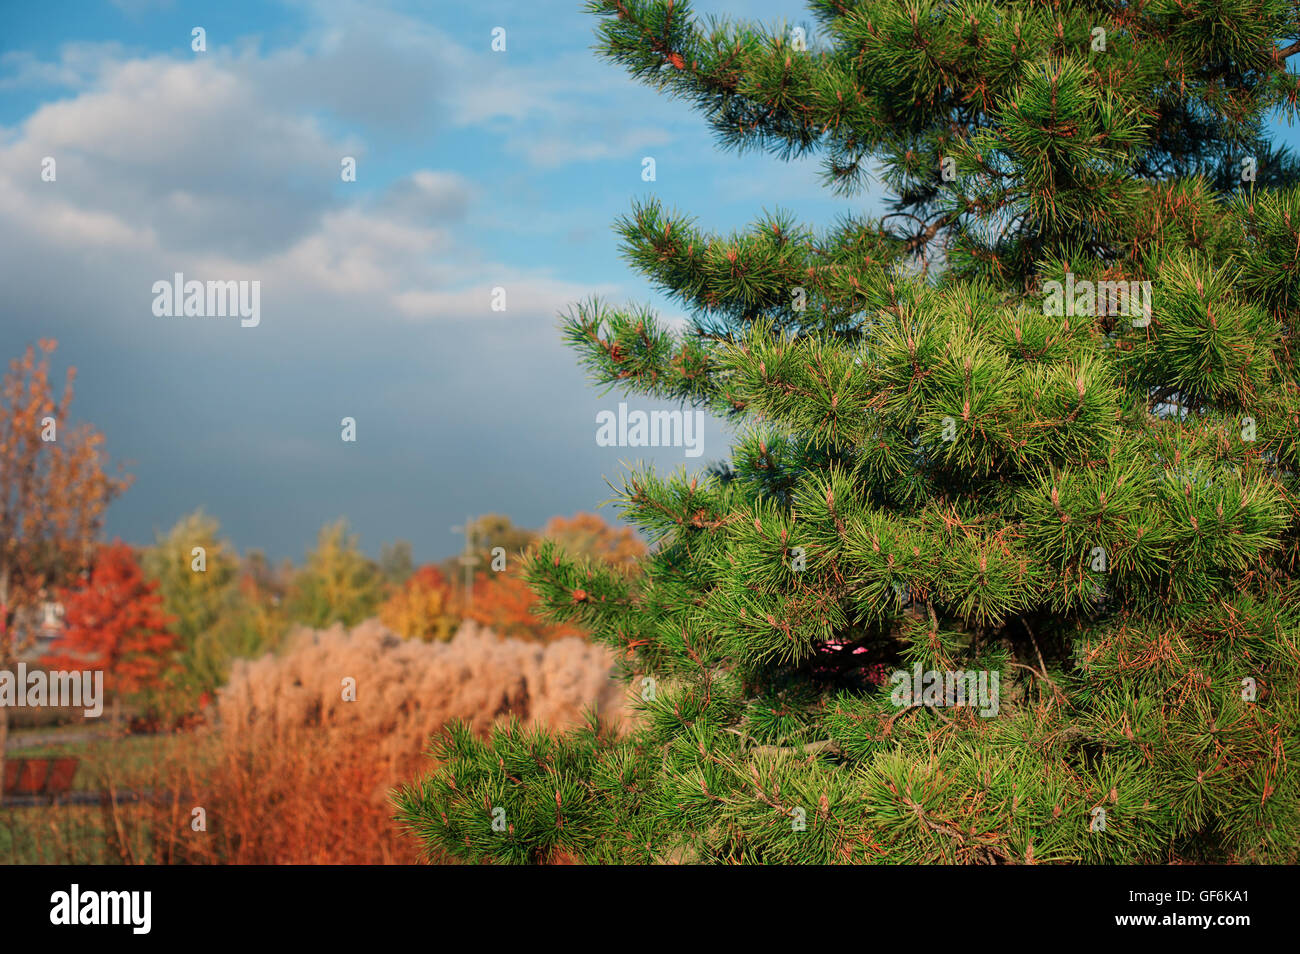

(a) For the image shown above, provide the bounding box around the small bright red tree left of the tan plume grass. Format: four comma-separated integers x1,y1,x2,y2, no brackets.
42,542,177,695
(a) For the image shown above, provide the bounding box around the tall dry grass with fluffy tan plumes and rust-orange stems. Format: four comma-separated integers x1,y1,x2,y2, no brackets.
135,620,624,864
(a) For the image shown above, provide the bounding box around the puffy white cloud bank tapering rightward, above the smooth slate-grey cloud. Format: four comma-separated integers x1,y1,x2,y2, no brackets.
0,50,548,330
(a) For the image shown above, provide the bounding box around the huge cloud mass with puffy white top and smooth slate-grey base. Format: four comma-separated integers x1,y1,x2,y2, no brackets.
0,31,724,566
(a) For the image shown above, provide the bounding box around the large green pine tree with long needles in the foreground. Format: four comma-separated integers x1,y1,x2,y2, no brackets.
397,0,1300,863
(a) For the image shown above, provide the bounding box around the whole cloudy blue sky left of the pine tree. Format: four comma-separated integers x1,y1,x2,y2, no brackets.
0,0,1296,560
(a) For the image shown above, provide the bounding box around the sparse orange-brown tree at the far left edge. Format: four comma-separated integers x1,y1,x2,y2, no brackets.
0,339,127,777
